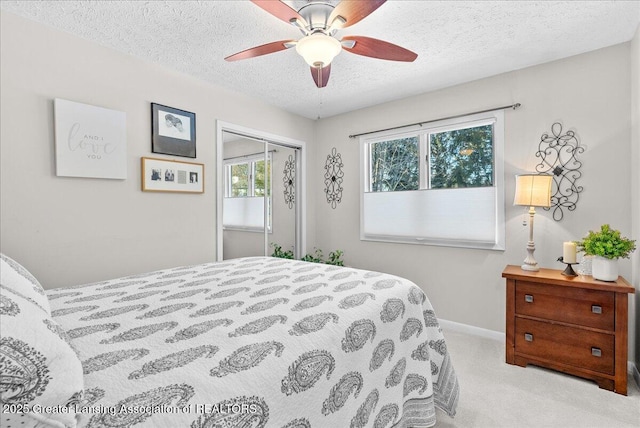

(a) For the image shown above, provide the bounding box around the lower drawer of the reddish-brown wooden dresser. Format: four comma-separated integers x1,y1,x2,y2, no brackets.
515,317,614,375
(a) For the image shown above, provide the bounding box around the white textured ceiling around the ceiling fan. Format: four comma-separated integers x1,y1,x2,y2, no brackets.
0,0,640,119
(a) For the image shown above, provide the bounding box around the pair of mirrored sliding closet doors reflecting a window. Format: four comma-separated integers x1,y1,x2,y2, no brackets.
221,127,303,260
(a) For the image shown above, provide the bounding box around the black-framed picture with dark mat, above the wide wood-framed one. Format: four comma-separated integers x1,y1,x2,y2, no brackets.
151,103,196,158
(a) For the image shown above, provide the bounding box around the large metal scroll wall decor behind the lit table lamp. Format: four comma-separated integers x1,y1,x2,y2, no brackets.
536,122,584,221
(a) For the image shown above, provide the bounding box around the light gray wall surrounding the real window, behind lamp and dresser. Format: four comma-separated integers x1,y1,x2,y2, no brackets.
313,43,638,358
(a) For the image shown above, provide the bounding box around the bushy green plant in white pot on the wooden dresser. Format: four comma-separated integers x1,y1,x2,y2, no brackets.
576,224,636,281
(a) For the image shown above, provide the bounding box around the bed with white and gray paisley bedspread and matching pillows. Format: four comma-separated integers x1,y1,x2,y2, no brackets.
0,256,459,428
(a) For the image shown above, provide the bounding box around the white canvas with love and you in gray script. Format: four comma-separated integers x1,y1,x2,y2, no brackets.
53,98,127,180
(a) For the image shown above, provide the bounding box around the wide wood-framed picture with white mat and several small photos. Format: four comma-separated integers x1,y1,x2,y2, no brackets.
140,157,204,193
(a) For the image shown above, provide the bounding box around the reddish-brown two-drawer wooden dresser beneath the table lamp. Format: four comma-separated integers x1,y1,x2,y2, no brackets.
502,265,635,395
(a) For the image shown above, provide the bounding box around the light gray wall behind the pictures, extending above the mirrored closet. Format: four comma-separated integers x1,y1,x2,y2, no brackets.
0,11,314,288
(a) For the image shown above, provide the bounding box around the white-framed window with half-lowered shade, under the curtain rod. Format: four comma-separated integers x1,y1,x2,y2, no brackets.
360,111,504,249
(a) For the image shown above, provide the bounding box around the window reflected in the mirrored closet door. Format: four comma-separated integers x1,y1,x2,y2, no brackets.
223,154,271,232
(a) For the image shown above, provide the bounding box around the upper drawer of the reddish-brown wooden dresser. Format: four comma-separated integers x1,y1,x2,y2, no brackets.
515,281,615,331
